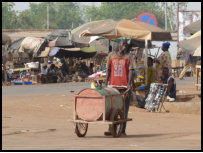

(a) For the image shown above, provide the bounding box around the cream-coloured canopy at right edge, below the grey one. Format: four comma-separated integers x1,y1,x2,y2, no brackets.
179,30,201,54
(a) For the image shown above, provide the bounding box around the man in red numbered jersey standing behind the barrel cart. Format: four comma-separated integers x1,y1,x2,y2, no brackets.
104,40,135,136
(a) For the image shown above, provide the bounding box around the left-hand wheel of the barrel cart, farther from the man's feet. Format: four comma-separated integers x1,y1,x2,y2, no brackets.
75,123,88,137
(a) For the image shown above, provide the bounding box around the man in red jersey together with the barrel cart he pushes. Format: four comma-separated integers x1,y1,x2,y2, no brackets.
70,40,135,137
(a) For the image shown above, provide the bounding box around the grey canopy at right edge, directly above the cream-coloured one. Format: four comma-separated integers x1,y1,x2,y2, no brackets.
183,20,201,34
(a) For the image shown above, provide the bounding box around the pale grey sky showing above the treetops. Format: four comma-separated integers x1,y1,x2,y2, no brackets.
14,2,201,11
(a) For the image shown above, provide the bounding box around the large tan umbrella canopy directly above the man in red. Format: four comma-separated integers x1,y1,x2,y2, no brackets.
80,19,172,41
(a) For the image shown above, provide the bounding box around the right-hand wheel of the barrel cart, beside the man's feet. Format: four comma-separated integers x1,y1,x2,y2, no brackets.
110,109,124,137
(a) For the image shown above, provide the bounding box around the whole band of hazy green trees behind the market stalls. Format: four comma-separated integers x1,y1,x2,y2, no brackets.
2,2,187,30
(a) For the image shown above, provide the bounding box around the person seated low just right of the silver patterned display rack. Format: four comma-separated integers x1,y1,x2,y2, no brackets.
161,67,176,102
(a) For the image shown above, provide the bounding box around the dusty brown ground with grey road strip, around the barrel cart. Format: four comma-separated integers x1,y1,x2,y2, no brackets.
2,78,201,150
